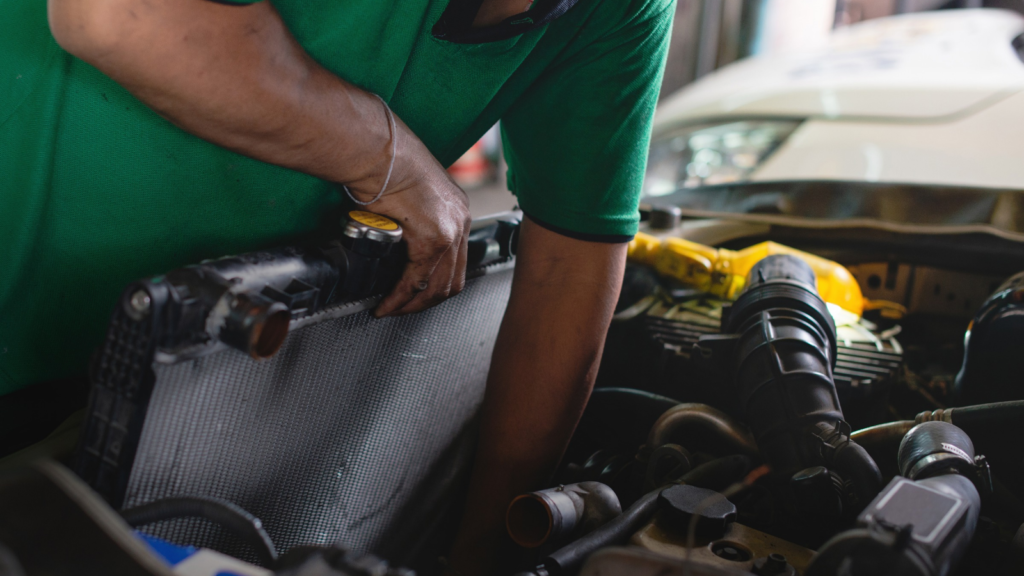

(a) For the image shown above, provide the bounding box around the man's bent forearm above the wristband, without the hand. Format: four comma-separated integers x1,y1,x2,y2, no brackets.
49,0,389,186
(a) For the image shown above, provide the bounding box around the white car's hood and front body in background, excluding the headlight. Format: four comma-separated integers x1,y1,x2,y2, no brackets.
654,9,1024,190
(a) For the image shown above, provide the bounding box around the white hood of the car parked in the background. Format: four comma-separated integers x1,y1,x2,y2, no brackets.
655,9,1024,125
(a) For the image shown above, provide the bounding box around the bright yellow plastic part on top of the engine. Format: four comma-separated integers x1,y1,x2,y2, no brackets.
629,233,864,317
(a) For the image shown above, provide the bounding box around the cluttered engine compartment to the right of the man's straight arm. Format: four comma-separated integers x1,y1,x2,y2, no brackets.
508,208,1024,576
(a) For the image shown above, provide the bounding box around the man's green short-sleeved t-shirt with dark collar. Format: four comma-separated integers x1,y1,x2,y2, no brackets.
0,0,674,394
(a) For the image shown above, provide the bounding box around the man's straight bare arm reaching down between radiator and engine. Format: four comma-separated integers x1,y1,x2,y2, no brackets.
452,217,626,576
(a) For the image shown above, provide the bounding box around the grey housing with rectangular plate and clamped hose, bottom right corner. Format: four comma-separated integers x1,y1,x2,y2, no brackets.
807,416,983,576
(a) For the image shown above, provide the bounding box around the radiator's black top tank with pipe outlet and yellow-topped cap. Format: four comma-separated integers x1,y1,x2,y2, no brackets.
122,210,403,359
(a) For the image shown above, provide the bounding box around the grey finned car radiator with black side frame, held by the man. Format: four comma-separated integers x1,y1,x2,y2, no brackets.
76,214,520,567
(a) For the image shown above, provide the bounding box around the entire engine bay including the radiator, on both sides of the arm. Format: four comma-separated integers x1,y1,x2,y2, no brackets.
0,207,1024,576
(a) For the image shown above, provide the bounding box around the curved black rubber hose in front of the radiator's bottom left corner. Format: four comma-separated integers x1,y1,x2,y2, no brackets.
121,496,278,567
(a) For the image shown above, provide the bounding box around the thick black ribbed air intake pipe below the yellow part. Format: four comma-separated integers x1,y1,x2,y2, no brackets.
694,254,882,509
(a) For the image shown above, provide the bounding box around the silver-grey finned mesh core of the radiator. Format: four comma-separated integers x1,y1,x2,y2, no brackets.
125,265,512,563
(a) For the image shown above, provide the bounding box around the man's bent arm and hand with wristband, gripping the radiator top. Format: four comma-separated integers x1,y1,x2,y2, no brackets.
48,0,470,315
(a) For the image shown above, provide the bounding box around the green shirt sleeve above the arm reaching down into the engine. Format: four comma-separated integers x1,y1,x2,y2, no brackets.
502,0,675,242
